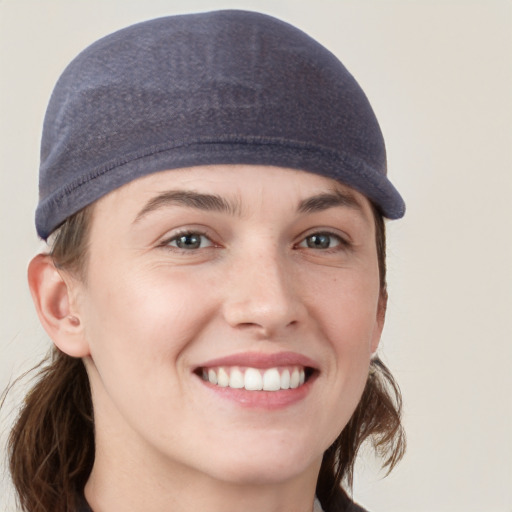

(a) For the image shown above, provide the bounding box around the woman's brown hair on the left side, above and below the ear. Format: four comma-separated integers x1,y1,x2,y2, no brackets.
4,208,94,512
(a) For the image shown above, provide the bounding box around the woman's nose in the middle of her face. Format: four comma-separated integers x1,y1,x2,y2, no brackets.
223,247,306,338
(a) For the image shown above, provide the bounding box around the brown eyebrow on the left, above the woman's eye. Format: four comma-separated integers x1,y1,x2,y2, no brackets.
134,190,240,222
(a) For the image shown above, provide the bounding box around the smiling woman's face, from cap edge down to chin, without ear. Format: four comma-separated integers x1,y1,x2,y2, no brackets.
72,166,383,483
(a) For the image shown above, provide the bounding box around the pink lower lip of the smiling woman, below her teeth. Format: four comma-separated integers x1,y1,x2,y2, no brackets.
196,374,316,410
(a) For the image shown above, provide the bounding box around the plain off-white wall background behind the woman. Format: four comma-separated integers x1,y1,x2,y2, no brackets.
0,0,512,512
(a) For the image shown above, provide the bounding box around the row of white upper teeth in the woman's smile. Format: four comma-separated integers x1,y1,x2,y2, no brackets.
202,367,306,391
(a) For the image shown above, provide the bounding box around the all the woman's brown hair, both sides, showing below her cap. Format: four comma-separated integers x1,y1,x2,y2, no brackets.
4,207,405,512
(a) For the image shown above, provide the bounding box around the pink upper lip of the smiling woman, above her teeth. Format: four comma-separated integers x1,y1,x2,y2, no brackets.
195,352,318,369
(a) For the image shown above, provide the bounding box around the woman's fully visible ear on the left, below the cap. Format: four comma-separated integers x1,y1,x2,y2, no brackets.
28,254,89,357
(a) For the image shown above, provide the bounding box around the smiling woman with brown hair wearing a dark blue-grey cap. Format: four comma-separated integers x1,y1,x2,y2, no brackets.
4,11,404,512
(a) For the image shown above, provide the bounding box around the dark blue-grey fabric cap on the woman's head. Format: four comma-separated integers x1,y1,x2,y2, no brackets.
36,10,405,238
